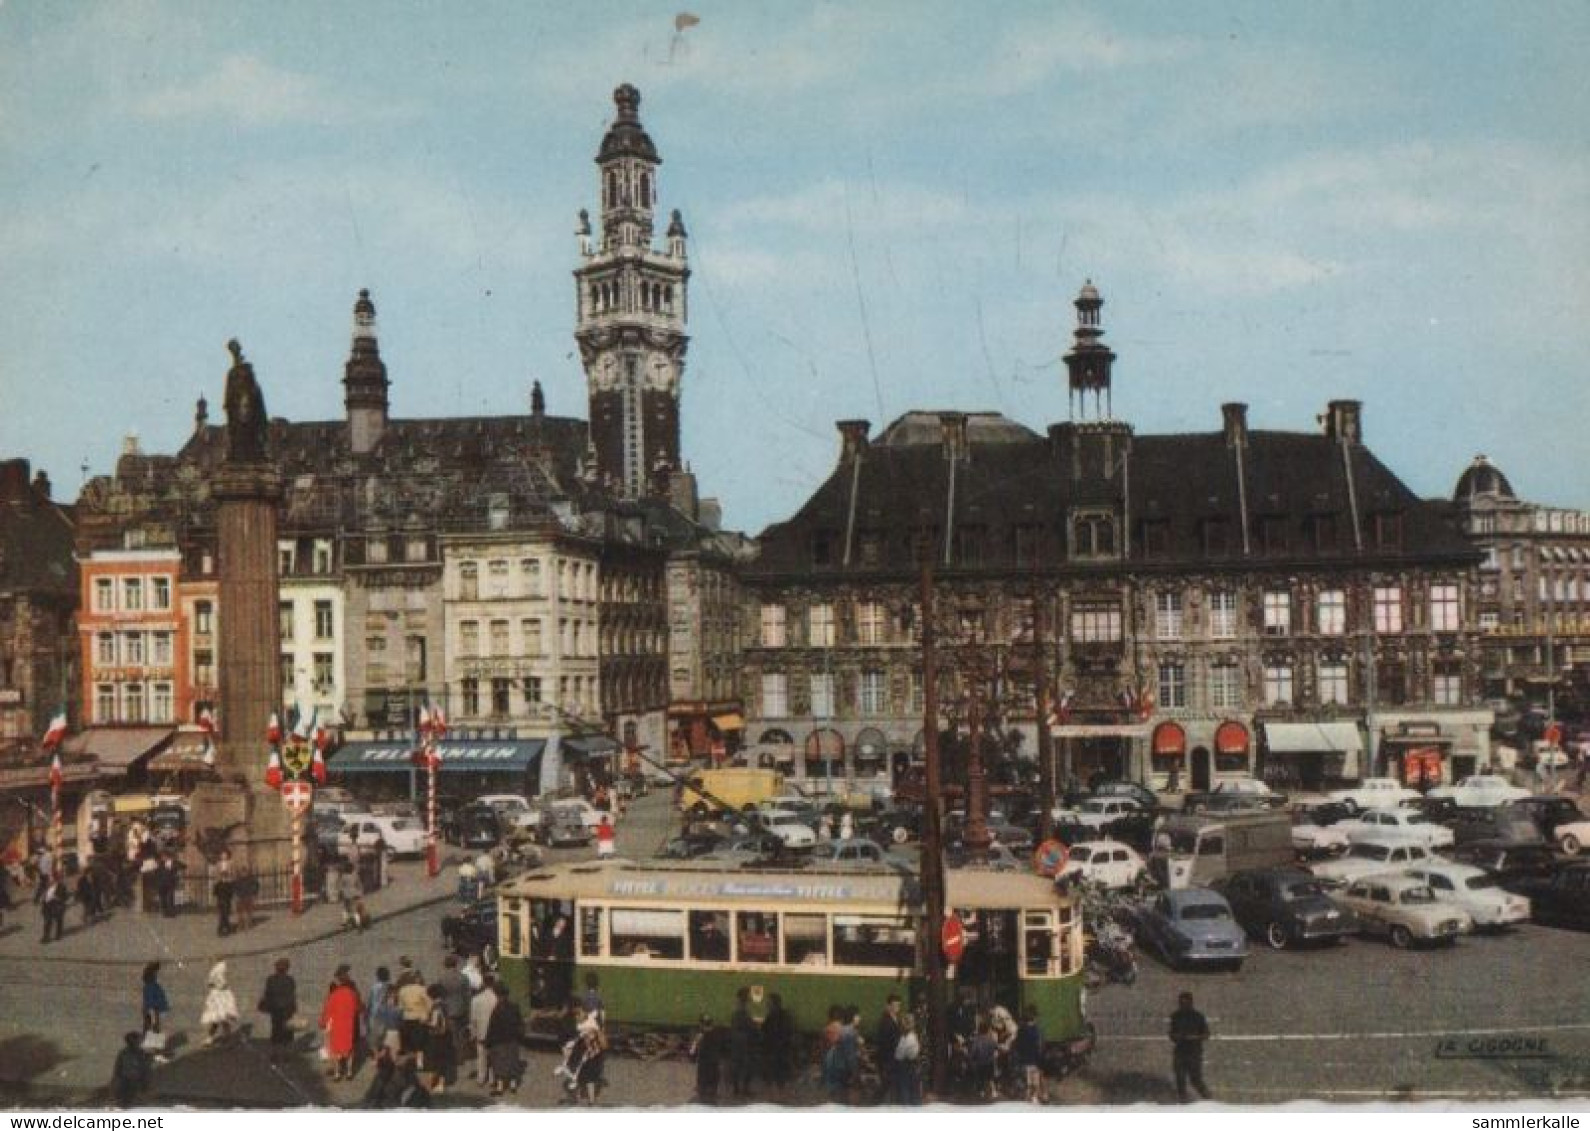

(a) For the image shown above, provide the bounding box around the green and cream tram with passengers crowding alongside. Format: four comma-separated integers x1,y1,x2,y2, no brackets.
498,861,1091,1056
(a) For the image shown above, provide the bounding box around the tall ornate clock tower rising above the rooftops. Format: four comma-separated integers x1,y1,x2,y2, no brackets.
574,83,690,498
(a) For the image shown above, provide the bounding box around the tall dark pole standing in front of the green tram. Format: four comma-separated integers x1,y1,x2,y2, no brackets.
922,562,949,1096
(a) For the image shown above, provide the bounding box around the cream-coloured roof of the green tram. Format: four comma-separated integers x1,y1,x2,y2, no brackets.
498,859,1062,908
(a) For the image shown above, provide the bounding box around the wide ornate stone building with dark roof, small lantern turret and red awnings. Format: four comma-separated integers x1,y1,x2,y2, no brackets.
741,285,1490,787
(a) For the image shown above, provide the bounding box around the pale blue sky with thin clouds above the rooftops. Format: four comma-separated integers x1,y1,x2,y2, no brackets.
0,0,1590,533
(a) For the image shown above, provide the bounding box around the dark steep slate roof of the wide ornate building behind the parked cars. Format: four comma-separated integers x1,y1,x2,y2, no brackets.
747,414,1476,577
